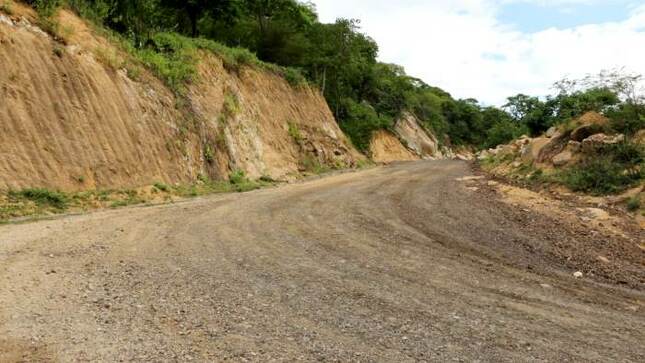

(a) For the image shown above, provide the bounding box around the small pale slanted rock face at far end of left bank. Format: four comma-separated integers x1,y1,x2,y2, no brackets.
394,112,442,158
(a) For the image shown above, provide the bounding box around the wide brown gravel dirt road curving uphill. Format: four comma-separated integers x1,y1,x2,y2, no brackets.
0,161,645,362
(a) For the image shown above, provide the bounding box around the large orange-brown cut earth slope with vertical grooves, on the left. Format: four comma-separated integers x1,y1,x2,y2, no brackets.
0,3,362,191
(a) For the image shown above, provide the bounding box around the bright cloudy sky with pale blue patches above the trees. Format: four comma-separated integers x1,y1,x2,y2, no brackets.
313,0,645,106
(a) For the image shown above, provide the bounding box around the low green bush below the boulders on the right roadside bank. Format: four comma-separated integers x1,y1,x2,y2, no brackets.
560,142,645,195
